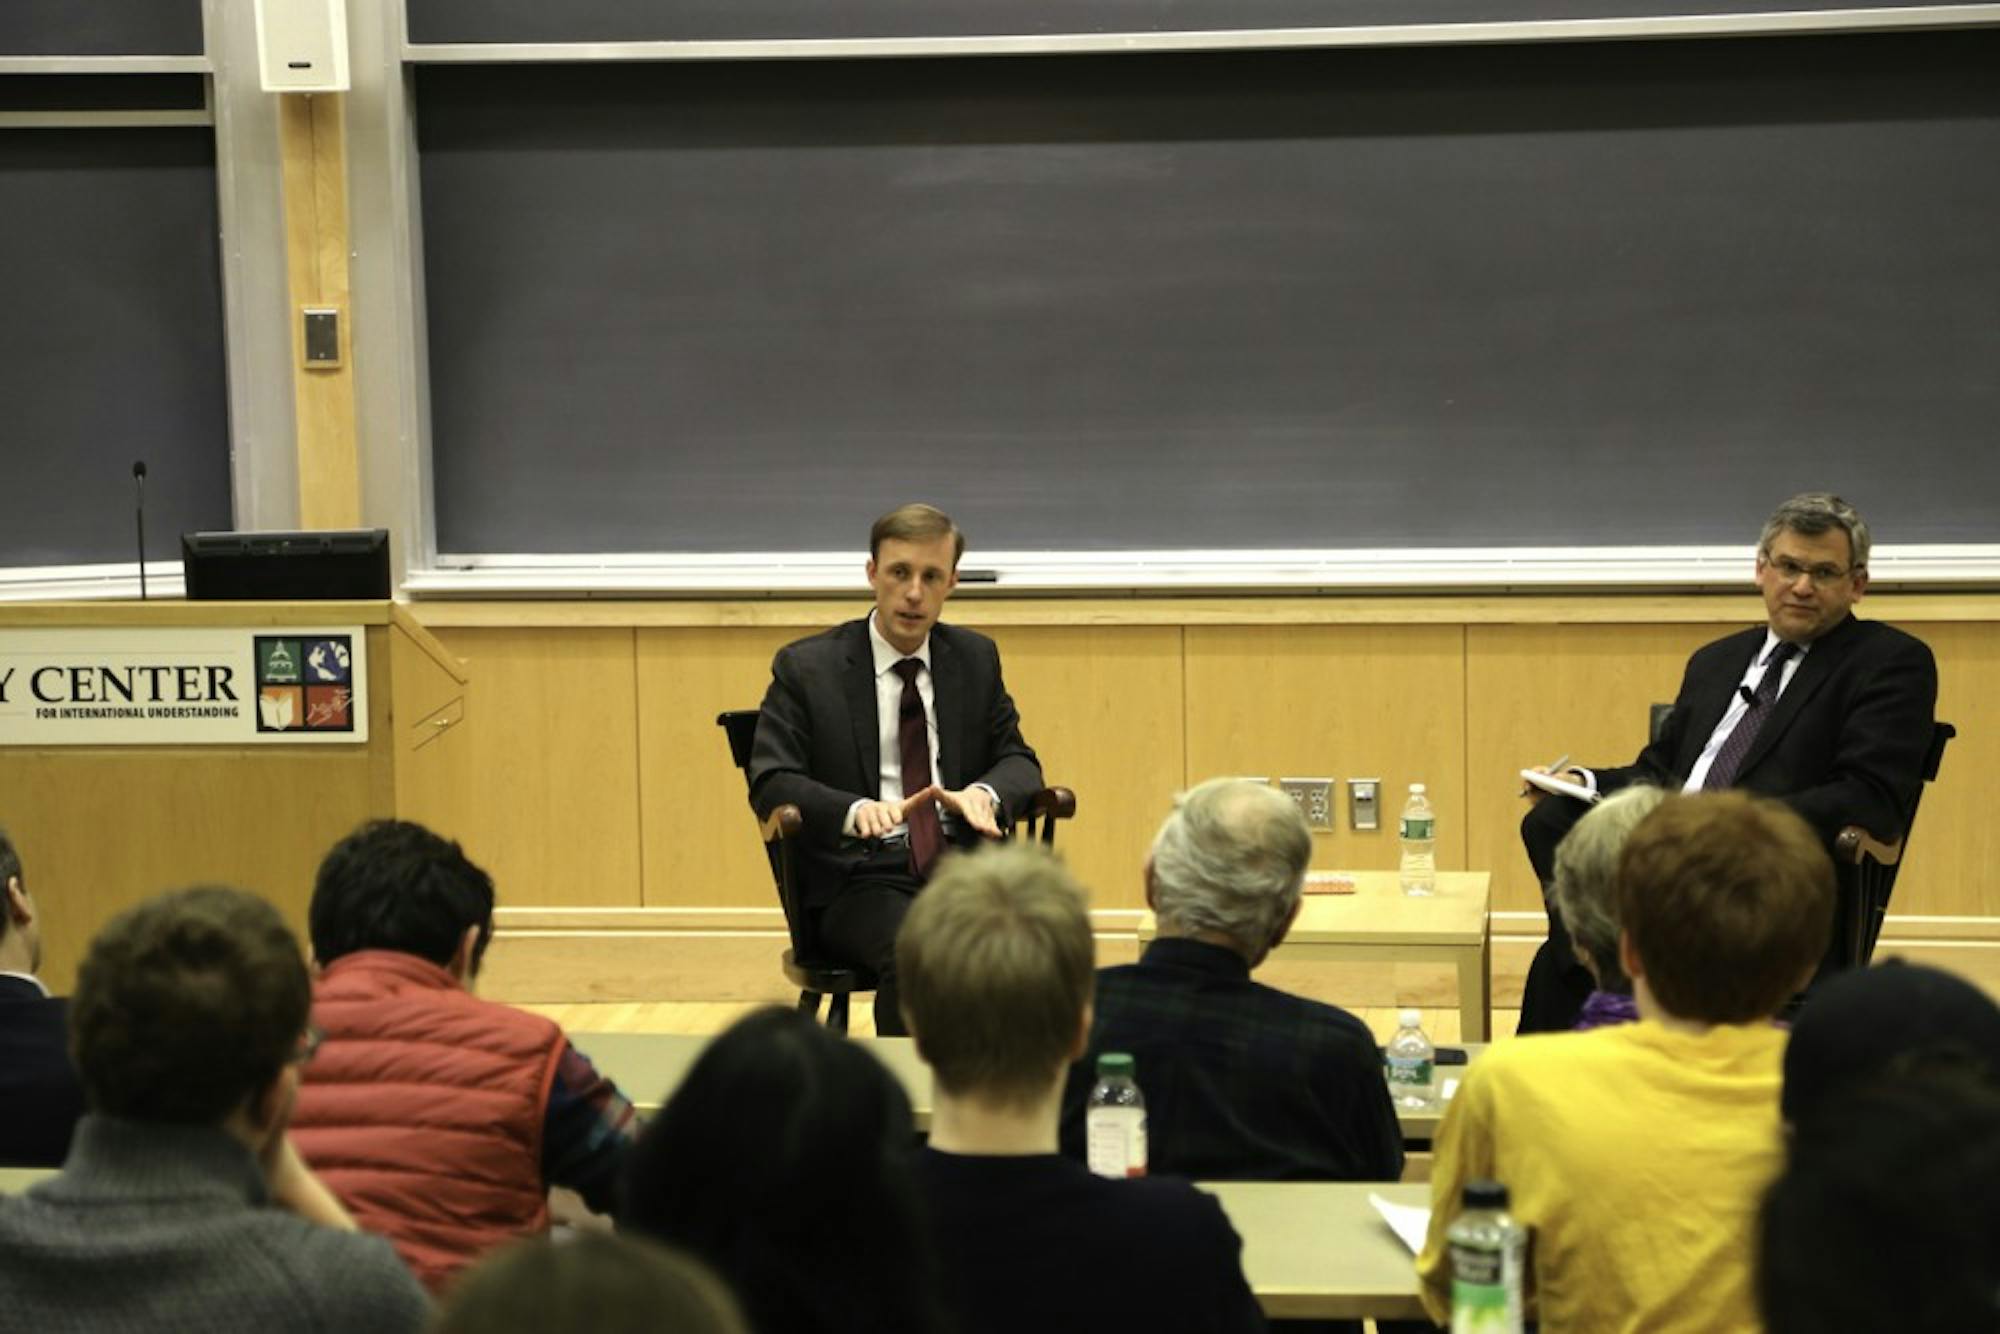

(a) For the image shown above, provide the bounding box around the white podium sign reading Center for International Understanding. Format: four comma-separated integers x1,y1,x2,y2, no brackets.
0,626,368,746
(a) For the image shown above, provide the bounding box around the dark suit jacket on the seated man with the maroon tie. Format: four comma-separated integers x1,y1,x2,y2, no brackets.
750,620,1042,906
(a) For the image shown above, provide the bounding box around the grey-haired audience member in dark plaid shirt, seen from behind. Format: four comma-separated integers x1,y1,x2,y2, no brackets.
1062,778,1402,1180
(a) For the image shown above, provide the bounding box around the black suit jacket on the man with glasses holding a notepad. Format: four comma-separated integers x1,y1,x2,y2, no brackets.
1598,616,1938,842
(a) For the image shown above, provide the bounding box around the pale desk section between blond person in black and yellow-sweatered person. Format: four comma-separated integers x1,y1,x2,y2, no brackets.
1200,1182,1430,1320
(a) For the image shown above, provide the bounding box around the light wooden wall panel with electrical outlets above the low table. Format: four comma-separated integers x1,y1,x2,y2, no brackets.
1186,624,1466,870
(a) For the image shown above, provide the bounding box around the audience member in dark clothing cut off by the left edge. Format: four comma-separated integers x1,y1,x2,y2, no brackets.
0,830,84,1168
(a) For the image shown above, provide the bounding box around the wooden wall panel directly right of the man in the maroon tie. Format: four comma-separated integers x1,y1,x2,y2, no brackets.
972,622,1186,908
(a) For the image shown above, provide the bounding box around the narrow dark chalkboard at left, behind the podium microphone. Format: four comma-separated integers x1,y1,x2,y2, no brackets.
0,126,230,566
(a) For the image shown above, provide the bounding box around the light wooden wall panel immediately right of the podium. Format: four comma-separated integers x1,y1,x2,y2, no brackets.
424,628,640,908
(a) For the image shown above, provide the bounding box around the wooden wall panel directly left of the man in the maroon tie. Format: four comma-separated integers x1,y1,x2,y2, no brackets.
638,628,804,908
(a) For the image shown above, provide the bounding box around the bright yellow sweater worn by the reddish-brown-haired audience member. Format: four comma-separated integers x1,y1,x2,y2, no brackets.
1416,1022,1786,1334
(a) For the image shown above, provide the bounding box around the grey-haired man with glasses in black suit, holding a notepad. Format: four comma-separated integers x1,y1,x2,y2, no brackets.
1520,492,1938,1032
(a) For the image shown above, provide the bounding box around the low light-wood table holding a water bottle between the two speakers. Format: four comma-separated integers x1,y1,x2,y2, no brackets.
1138,870,1492,1042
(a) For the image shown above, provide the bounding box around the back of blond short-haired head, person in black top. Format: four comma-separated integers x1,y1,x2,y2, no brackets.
896,844,1096,1108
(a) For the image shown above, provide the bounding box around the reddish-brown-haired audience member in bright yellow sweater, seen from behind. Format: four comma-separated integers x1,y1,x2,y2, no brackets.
1418,792,1834,1334
